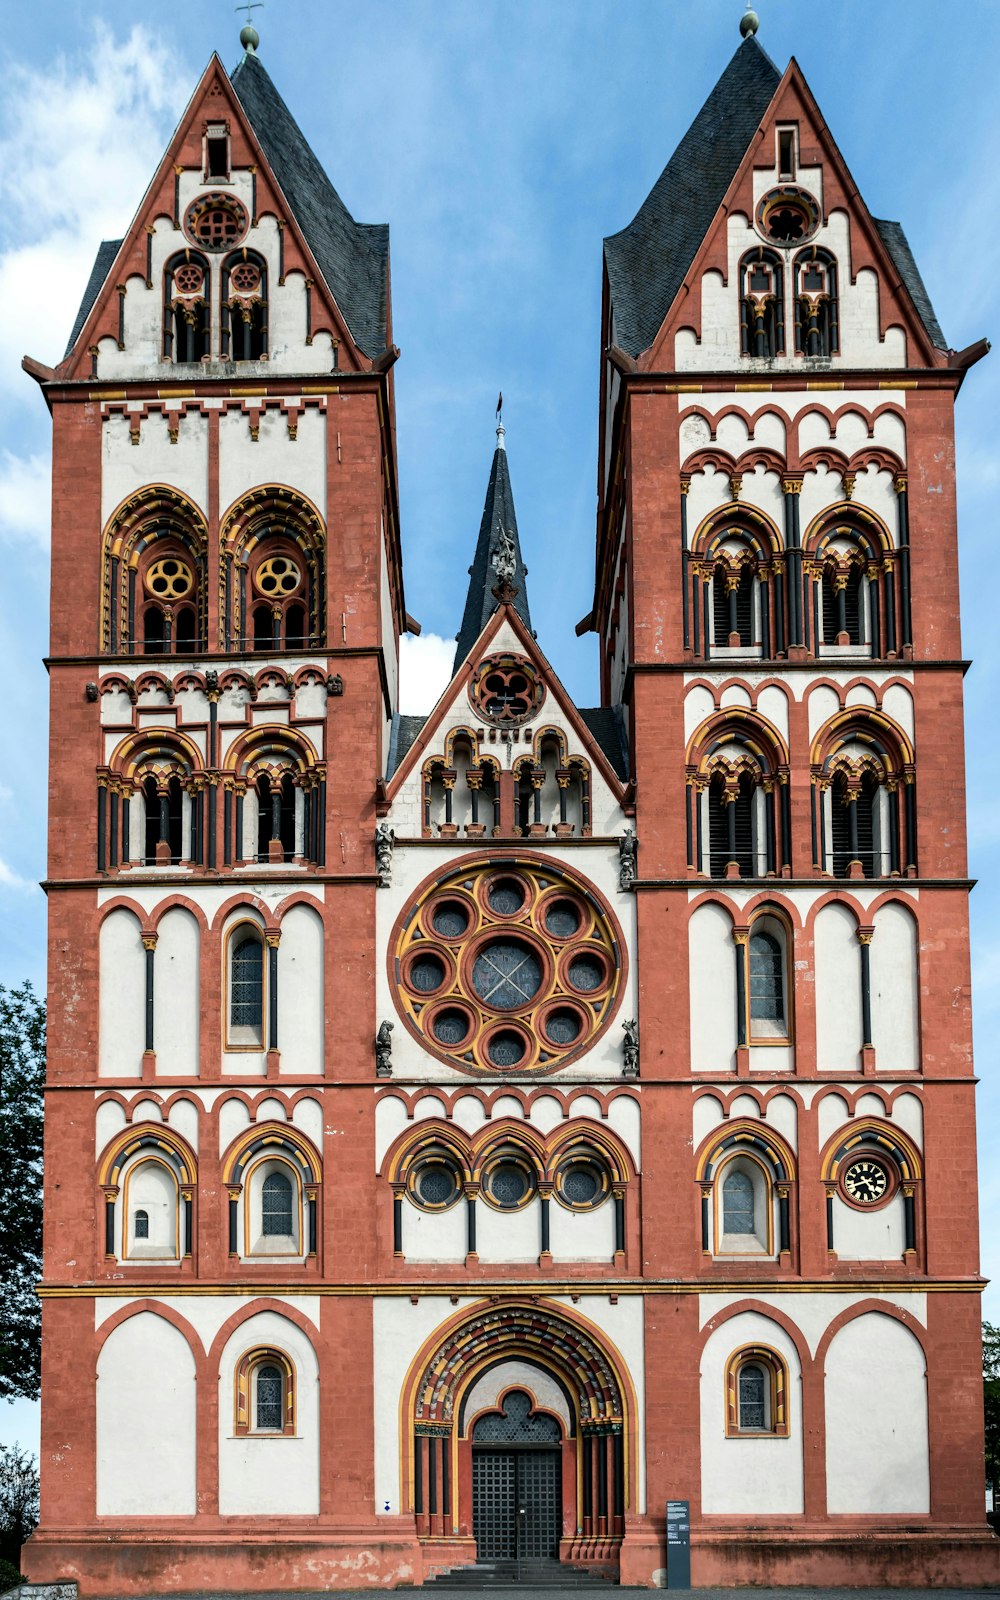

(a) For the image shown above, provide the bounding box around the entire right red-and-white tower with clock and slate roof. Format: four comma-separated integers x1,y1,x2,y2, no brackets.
589,16,995,1584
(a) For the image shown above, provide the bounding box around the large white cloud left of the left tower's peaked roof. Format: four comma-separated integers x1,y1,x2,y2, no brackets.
0,24,190,385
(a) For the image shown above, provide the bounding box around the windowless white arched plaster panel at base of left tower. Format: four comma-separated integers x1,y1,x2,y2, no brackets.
96,1310,195,1517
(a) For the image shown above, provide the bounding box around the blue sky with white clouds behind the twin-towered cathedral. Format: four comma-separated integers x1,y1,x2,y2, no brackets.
0,0,1000,1443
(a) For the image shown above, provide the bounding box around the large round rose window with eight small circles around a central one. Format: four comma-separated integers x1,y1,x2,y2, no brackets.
390,859,626,1074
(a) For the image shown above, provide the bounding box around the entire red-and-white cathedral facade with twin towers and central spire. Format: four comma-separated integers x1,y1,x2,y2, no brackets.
24,24,997,1594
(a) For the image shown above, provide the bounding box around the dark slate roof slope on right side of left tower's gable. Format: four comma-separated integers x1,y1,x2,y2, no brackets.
232,54,389,357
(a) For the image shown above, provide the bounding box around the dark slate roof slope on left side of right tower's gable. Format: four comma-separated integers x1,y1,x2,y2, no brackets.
605,35,781,355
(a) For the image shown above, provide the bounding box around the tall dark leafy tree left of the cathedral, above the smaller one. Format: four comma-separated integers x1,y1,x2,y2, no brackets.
0,984,45,1400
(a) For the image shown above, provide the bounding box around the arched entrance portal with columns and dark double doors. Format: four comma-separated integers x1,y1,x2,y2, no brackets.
402,1302,635,1568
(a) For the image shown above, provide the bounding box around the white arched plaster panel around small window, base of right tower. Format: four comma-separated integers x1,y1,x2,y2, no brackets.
701,1312,803,1517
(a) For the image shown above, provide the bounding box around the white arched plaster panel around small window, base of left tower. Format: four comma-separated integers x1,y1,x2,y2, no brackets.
219,1310,320,1517
